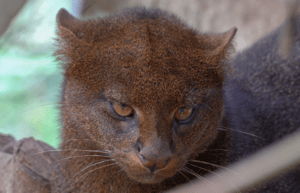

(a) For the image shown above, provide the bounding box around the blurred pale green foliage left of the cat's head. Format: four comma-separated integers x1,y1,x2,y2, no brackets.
0,0,71,148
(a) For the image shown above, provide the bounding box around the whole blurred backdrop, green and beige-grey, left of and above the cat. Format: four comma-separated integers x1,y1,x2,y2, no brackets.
0,0,287,147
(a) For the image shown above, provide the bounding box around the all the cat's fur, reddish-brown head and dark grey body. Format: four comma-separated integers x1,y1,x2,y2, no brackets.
52,8,300,193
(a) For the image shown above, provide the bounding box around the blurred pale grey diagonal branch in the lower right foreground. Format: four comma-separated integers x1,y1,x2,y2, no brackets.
168,132,300,193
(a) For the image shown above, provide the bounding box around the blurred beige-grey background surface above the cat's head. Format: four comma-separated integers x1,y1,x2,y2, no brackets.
82,0,287,51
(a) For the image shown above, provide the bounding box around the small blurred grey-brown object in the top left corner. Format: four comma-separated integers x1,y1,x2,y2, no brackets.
0,0,27,37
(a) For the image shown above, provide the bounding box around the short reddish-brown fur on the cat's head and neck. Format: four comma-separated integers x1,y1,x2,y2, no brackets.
52,8,236,193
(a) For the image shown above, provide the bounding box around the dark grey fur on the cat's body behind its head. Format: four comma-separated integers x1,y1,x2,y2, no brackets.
224,16,300,193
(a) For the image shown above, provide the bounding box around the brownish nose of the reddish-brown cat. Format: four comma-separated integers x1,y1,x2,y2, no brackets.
137,142,171,173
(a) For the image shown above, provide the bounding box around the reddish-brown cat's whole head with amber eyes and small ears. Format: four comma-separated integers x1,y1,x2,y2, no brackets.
56,8,236,183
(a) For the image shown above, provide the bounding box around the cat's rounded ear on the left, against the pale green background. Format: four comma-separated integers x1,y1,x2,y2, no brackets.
56,8,83,41
